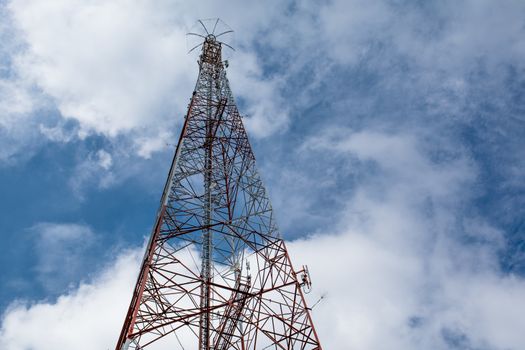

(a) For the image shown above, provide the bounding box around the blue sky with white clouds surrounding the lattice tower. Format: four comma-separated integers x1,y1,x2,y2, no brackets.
0,0,525,350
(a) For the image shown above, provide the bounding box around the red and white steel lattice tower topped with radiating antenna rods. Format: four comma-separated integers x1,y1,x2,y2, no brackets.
116,20,321,350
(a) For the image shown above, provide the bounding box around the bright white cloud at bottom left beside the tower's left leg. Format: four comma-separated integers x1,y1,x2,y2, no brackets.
0,246,141,350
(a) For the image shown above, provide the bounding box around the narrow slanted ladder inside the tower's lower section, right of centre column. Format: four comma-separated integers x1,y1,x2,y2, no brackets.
213,274,251,350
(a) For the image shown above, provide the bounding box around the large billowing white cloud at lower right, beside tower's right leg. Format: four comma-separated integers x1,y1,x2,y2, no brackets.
291,130,525,349
